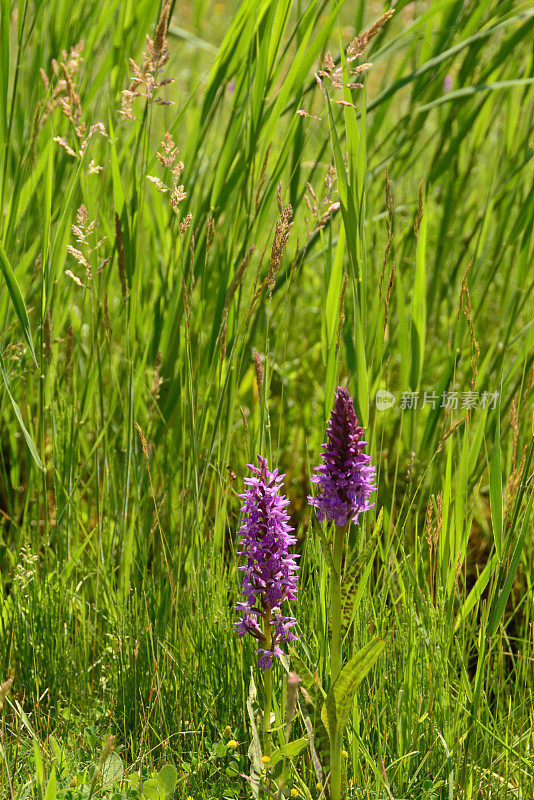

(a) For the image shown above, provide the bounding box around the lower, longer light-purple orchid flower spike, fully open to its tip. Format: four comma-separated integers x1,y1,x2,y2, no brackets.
235,456,299,669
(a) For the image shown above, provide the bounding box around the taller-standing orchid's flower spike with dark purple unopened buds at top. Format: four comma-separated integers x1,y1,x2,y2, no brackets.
308,386,376,526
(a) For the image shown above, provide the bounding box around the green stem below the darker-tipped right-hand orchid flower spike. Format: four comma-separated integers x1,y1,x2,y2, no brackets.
330,525,348,800
